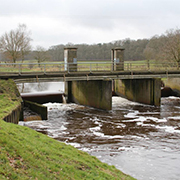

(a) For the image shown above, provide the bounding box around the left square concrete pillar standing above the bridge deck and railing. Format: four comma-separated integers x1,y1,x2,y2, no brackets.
64,47,77,72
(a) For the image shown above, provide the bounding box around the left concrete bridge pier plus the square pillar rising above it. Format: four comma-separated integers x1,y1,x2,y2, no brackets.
64,47,112,110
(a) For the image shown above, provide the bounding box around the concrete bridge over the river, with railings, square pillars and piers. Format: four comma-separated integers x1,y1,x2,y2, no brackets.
0,48,180,110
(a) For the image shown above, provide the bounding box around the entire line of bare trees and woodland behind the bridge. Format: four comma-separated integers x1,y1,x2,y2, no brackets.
0,24,180,64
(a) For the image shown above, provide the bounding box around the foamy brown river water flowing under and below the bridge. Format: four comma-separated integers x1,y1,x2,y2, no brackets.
19,83,180,180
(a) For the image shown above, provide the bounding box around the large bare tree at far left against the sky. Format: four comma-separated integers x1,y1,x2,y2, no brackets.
0,24,32,63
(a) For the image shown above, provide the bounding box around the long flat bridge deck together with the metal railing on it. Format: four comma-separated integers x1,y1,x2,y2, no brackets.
0,62,180,82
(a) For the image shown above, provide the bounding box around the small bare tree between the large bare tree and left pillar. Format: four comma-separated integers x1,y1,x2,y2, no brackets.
34,46,50,66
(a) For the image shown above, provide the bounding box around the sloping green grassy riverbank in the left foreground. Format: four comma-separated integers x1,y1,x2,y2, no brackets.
0,81,134,180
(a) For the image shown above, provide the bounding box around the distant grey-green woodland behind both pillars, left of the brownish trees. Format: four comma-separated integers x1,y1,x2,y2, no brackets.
48,39,149,61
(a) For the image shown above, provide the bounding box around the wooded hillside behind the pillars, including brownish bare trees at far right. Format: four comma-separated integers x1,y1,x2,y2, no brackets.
48,29,180,62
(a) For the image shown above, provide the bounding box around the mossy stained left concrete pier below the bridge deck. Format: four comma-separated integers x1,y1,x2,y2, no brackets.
65,80,112,110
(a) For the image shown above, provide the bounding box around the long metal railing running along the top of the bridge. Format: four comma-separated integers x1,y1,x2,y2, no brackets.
0,61,179,74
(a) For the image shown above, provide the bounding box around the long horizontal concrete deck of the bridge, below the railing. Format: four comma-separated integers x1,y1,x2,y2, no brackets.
0,71,180,82
